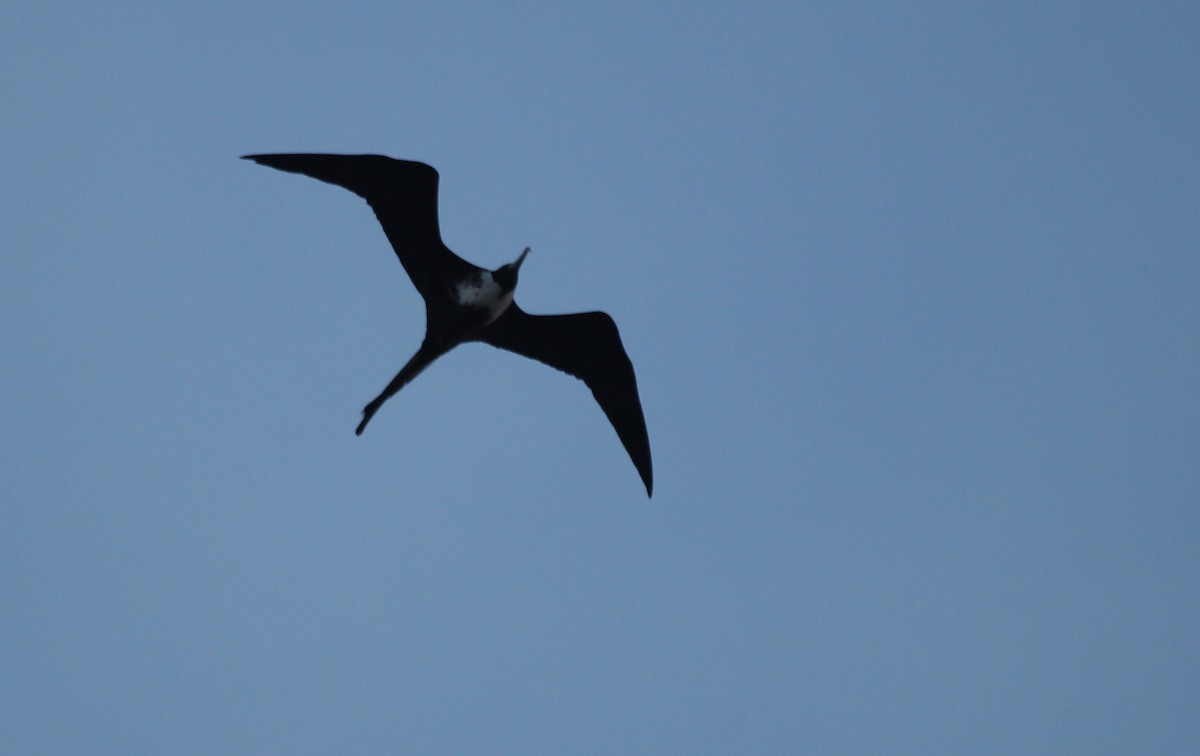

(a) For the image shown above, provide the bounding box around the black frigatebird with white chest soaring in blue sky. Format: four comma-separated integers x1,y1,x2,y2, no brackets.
242,154,654,496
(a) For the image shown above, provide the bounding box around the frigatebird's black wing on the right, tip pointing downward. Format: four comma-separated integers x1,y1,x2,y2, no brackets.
476,302,654,494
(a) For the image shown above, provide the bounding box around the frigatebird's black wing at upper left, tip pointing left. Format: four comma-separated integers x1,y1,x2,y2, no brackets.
244,154,480,300
